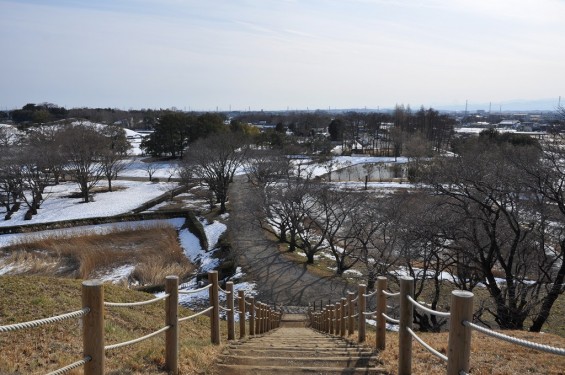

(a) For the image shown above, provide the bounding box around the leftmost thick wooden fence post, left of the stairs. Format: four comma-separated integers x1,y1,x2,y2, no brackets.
82,280,105,375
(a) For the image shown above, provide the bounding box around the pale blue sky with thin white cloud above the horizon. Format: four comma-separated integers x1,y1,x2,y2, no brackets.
0,0,565,111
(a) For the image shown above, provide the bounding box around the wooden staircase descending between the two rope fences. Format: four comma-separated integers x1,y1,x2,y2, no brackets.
214,314,386,375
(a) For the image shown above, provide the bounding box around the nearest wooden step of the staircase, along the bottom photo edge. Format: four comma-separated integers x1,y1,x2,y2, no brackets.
218,364,387,375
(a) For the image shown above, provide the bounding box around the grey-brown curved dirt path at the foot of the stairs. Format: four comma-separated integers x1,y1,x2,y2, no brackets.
229,177,355,306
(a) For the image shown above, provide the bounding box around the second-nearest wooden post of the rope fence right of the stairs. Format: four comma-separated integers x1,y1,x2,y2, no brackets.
398,276,414,375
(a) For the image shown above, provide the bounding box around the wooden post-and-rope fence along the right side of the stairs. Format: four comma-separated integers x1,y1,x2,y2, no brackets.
309,276,565,375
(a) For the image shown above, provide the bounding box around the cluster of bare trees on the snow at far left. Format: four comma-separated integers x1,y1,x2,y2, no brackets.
0,122,131,220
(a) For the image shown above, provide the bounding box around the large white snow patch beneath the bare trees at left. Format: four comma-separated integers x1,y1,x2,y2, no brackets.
0,181,170,226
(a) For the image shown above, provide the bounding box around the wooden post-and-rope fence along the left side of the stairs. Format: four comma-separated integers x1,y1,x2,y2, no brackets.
0,271,281,375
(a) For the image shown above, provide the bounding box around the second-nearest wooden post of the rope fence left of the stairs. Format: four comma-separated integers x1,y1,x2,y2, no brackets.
165,276,179,375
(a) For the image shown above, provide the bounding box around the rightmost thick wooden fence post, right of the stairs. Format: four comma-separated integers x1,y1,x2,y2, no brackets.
447,290,473,375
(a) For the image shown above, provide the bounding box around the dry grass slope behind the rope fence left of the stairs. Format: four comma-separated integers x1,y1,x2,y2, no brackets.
0,276,226,375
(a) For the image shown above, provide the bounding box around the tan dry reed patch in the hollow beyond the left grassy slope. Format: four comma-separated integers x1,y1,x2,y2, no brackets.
3,225,193,285
